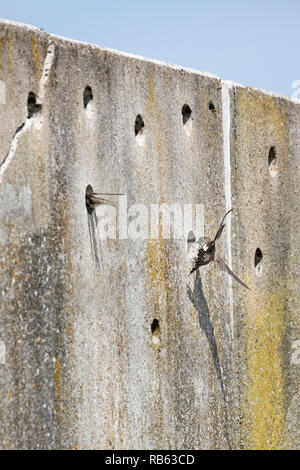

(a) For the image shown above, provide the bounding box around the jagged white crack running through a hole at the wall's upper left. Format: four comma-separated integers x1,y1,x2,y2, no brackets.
0,42,55,184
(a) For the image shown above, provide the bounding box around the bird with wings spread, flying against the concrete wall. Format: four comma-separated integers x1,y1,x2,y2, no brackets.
190,209,250,289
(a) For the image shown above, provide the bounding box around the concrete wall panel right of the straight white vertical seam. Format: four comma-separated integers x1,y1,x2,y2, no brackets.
231,86,300,449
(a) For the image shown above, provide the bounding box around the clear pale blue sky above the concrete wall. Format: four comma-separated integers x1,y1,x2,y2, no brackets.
0,0,300,95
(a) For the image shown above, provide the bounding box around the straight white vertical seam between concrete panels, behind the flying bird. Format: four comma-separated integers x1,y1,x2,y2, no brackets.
221,80,234,340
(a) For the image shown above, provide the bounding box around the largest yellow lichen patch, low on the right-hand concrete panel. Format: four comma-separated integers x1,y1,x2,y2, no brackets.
244,287,286,449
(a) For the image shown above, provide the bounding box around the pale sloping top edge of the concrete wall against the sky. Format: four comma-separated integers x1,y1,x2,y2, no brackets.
0,18,300,104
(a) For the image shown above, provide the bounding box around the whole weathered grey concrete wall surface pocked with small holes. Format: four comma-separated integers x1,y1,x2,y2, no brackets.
0,22,300,449
